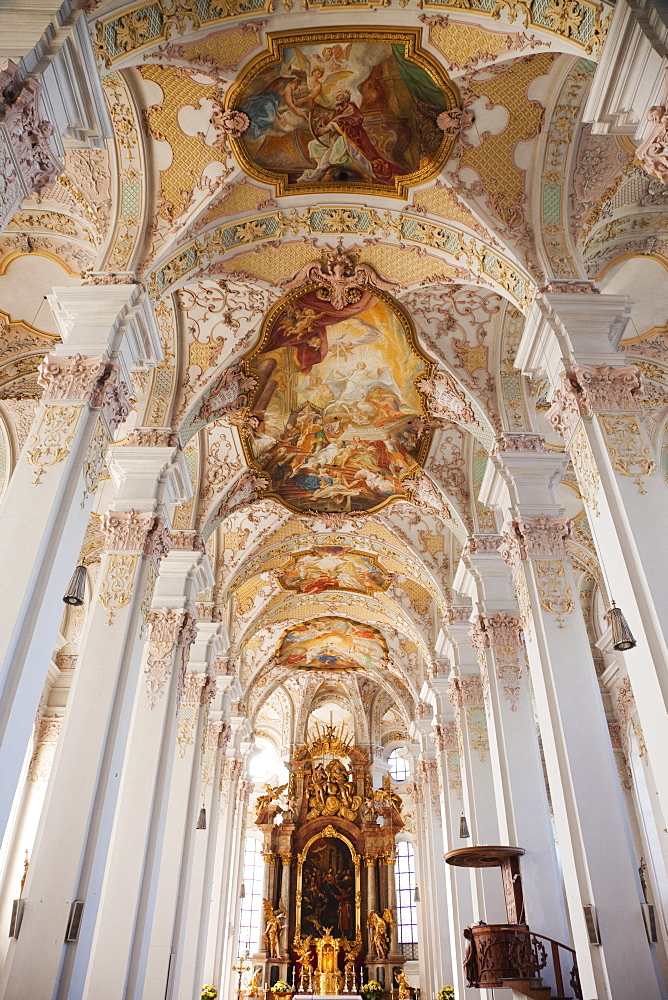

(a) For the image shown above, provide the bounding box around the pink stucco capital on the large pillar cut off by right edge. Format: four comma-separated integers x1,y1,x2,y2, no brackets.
547,364,642,440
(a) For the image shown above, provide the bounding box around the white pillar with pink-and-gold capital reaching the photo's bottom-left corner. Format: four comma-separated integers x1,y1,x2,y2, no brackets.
2,445,184,1000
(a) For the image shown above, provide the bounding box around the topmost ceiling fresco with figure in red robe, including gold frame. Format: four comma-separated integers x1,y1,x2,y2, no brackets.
227,28,459,197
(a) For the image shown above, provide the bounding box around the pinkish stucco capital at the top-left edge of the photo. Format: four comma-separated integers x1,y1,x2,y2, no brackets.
0,60,64,230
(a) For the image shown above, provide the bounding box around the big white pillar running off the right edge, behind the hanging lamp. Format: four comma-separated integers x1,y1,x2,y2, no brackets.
516,285,668,836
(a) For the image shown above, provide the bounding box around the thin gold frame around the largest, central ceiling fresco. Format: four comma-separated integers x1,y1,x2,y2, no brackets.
239,282,436,517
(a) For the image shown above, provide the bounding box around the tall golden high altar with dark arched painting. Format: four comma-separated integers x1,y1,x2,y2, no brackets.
253,725,404,996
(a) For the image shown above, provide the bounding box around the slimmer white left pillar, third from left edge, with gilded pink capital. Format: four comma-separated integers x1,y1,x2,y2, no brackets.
75,533,213,1000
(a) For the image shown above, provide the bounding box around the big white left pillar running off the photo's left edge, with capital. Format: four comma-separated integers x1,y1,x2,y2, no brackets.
0,285,162,836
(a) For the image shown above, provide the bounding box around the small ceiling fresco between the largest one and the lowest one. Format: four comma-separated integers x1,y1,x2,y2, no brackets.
278,545,389,594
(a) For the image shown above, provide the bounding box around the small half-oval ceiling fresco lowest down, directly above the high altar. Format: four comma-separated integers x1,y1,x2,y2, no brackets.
276,618,388,670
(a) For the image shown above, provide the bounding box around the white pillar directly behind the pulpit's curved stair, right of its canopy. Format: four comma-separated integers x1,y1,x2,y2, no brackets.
453,535,570,944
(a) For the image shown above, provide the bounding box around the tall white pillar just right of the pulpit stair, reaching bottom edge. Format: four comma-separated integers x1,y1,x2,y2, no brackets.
480,447,662,1000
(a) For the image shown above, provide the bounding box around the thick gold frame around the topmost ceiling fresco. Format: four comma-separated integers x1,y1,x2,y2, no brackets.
225,26,460,198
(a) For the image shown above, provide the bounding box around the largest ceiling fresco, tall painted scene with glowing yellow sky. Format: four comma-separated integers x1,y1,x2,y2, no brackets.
243,285,433,513
